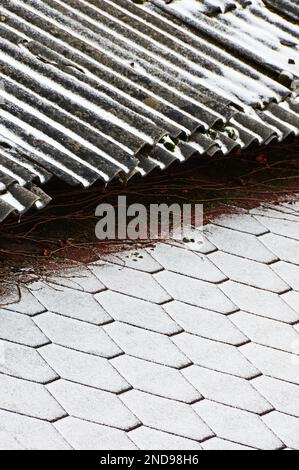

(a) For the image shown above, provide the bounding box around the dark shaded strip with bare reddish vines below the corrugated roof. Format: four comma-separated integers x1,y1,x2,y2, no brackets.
0,139,299,298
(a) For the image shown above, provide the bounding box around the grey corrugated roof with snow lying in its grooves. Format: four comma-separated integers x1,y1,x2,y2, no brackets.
0,0,299,220
